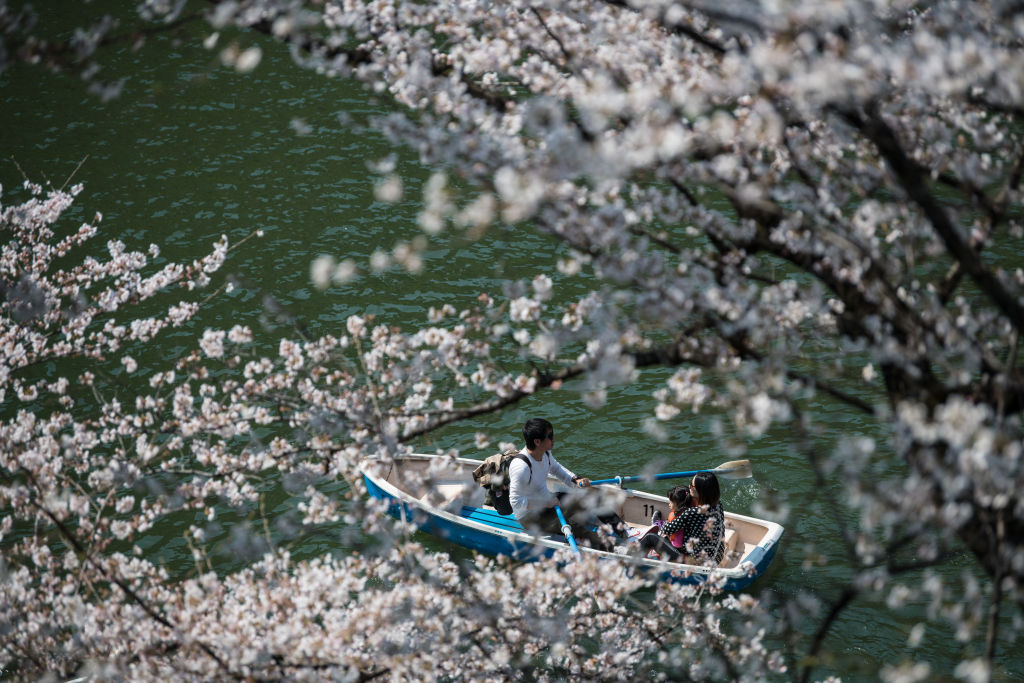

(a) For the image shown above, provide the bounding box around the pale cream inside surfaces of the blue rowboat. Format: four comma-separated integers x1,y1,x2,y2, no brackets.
372,457,768,568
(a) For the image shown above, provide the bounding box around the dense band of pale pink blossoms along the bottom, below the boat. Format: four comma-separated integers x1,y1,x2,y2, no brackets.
2,544,783,680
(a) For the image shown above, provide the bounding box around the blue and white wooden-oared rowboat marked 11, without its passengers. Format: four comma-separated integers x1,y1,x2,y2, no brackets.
360,454,783,591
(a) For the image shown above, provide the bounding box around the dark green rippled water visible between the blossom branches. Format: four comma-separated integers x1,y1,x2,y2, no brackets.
0,6,1024,680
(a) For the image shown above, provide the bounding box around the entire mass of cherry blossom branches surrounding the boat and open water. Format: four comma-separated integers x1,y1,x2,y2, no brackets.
6,0,1024,680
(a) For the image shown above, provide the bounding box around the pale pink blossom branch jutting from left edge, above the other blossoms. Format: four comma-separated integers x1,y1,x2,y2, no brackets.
0,183,227,405
